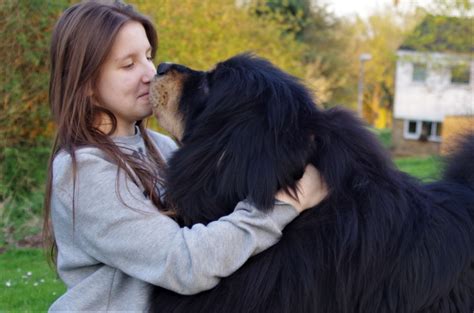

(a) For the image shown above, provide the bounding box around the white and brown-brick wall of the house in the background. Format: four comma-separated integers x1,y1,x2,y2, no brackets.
392,50,474,155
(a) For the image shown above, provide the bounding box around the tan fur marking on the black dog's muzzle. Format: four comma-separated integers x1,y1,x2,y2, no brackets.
150,70,186,141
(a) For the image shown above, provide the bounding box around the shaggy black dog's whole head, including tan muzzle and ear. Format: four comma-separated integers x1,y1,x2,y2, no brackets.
150,54,316,222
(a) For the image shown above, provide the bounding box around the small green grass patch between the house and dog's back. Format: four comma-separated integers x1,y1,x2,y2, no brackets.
395,156,442,182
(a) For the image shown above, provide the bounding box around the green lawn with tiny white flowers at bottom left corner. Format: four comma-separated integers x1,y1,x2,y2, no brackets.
0,249,66,312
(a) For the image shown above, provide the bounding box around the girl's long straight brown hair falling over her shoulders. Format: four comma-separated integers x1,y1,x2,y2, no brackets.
43,1,165,262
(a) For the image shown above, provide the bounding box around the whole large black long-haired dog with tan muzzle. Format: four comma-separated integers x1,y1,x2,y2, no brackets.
151,55,474,313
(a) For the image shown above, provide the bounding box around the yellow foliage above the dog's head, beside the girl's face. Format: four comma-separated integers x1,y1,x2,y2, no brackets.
137,0,303,76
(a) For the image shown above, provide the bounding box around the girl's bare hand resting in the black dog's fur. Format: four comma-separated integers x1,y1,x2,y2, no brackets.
275,164,328,213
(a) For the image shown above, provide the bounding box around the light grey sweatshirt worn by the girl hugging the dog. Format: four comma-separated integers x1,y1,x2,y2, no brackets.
49,131,298,312
